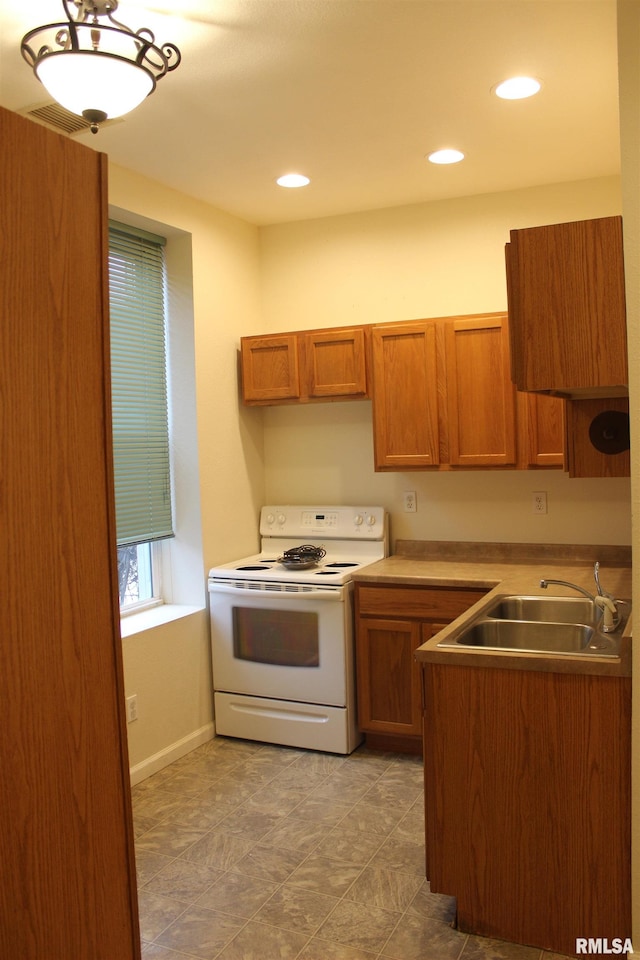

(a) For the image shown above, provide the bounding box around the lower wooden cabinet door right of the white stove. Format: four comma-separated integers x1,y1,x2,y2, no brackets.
357,618,422,737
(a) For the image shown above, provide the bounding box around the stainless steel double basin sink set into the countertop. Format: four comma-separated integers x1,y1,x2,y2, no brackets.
438,595,631,657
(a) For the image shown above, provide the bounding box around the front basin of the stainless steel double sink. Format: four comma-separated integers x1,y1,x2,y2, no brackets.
450,620,596,653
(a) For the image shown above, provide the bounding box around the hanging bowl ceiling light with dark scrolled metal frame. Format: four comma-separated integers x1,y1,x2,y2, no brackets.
20,0,181,133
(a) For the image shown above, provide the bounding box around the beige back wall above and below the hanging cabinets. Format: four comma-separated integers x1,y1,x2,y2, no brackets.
260,177,631,544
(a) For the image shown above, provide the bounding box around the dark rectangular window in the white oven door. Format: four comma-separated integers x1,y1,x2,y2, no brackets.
233,607,320,667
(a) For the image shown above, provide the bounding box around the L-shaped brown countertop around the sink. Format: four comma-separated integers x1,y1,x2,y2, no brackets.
354,541,631,676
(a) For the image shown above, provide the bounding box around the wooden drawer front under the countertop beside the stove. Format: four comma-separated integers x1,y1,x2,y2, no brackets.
356,584,488,622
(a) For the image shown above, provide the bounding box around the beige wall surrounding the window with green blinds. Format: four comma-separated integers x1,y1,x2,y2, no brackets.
109,166,264,768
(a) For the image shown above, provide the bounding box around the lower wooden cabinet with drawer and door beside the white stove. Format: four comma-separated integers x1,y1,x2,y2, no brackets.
355,583,484,753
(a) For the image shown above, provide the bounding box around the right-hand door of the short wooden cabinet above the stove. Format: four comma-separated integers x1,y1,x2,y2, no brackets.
304,327,367,399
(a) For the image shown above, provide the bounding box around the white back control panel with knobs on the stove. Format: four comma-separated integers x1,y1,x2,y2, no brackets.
260,504,387,540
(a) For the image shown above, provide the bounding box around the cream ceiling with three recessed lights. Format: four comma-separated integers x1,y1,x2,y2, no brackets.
0,0,620,225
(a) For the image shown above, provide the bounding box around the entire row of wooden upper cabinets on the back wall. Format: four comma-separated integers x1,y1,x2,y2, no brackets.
241,313,565,470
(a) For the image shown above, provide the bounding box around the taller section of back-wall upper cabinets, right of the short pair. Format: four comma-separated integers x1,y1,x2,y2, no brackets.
371,313,564,470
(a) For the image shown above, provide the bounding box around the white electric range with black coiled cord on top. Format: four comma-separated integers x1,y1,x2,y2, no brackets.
209,505,389,754
